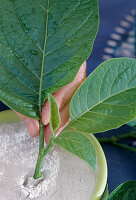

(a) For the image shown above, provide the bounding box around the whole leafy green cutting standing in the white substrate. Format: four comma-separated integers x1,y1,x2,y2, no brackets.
0,0,136,199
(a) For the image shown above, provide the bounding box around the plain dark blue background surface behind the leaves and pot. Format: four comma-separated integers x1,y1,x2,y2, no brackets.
0,0,136,194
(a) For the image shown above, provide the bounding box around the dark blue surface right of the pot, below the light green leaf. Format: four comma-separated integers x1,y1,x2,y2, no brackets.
95,125,136,192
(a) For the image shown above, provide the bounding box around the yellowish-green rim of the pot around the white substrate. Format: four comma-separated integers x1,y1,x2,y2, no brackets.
0,110,107,200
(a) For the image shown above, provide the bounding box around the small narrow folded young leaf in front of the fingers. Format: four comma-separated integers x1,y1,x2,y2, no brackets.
48,93,61,132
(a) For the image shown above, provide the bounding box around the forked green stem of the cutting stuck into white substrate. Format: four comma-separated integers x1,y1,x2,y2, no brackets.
33,120,54,179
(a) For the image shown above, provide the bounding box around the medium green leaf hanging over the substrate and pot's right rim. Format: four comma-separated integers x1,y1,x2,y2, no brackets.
54,129,96,170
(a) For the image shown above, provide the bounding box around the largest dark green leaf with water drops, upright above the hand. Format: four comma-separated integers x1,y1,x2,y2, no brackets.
0,0,98,119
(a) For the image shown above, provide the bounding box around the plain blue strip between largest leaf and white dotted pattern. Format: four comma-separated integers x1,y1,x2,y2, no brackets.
87,0,136,74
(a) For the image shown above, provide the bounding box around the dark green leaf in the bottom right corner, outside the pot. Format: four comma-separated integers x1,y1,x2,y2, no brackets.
108,181,136,200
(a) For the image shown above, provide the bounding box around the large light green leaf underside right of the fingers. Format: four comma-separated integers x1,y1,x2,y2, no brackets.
66,58,136,133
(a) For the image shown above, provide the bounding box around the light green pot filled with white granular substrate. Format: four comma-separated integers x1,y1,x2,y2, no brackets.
0,111,107,200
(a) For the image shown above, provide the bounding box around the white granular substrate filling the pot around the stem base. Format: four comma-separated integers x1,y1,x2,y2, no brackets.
0,123,95,200
